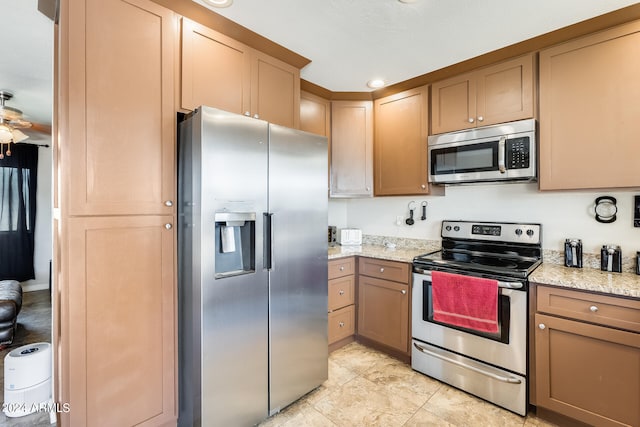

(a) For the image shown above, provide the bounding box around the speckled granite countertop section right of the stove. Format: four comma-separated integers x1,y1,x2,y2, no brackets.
529,263,640,298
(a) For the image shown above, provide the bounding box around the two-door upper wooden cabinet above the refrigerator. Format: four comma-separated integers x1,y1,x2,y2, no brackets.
181,18,300,128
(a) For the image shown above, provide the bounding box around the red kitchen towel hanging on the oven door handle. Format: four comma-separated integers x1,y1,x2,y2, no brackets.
431,271,498,333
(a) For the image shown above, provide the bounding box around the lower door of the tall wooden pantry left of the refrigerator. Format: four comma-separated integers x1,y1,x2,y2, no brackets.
66,216,177,426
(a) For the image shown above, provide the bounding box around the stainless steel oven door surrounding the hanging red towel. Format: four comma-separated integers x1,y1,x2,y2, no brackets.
411,271,527,375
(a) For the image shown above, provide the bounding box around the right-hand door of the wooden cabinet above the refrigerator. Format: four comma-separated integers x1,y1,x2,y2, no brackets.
251,50,300,129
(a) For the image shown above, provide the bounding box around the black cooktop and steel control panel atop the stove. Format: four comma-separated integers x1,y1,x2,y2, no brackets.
413,221,542,278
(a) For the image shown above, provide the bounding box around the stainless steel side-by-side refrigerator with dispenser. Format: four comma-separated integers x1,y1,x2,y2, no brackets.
178,107,328,427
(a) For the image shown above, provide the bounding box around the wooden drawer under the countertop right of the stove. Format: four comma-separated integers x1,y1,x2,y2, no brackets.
536,286,640,332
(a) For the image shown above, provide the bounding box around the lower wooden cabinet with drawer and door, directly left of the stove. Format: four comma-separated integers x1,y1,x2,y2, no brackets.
357,258,411,355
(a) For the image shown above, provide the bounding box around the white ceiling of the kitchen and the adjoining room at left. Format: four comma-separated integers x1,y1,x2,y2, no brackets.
0,0,637,133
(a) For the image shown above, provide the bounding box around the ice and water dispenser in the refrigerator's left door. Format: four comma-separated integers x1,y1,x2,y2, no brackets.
215,212,256,279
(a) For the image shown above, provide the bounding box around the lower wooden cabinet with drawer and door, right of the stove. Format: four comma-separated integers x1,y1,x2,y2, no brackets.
534,286,640,426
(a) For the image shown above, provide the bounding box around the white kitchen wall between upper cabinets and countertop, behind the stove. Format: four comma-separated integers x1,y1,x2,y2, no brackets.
329,183,640,256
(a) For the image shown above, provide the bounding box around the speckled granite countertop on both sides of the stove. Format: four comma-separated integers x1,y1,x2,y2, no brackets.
329,239,640,298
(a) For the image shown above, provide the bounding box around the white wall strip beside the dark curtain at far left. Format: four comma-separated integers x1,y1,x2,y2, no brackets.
22,142,53,292
